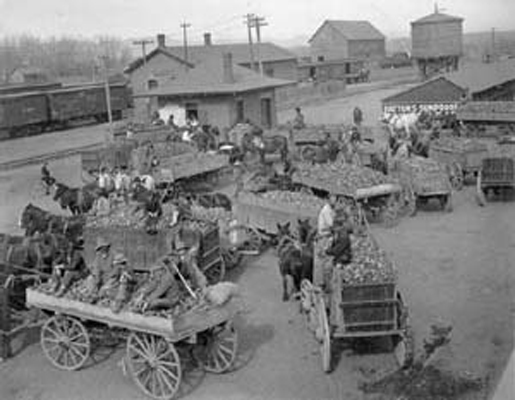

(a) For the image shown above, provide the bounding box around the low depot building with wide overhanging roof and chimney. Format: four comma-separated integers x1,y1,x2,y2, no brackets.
134,45,296,129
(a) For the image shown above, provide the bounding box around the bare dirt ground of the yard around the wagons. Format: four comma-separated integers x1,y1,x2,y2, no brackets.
0,85,515,400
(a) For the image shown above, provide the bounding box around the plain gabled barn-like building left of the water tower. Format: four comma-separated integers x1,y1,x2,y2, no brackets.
308,20,386,62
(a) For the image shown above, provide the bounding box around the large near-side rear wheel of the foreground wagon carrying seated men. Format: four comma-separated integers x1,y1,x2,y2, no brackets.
126,332,182,400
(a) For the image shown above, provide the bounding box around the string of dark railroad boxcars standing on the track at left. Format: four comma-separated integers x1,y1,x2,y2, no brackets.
0,83,131,140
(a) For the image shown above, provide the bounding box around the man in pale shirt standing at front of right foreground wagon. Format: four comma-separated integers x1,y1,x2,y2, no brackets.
313,194,336,286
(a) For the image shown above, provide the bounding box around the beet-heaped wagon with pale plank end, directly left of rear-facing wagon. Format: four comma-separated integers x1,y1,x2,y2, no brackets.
292,160,405,226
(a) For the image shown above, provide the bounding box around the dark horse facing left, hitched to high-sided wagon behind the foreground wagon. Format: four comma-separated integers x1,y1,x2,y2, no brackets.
20,203,85,242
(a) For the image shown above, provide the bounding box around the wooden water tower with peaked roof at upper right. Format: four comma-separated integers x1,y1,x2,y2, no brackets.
411,6,463,79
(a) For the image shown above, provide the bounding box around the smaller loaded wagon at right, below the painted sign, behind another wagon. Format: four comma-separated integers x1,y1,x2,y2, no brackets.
429,138,488,190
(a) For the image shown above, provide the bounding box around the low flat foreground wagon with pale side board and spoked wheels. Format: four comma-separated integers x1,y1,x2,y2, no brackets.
27,288,242,400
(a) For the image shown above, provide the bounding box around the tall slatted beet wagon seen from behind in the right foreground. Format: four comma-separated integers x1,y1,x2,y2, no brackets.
300,232,414,372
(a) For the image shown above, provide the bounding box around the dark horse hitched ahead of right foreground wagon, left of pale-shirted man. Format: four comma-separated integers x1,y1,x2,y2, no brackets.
277,222,313,301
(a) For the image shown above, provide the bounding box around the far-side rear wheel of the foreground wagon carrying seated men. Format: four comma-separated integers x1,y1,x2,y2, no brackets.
204,322,238,374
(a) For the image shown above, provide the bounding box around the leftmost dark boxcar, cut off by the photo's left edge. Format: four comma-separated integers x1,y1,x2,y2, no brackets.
0,92,49,139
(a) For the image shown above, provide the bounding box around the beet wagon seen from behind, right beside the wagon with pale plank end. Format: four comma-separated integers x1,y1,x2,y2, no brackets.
390,155,452,215
